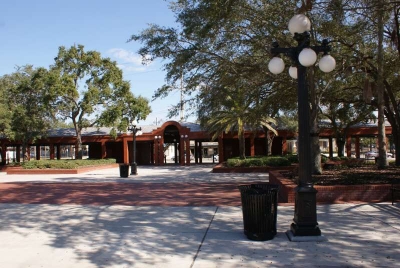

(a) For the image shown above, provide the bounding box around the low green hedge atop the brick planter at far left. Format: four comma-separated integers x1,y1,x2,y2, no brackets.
21,158,116,169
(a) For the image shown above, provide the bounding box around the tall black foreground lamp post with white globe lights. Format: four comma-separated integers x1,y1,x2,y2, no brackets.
268,15,336,241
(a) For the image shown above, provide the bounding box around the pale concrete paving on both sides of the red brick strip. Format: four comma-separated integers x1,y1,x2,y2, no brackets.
0,166,400,268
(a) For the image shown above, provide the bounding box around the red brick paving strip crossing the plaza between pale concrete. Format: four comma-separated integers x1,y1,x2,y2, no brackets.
0,183,264,206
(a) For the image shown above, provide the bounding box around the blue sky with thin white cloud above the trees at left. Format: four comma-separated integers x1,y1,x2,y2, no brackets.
0,0,193,125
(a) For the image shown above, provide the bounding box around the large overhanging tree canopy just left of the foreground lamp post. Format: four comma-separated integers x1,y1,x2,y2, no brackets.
129,0,296,123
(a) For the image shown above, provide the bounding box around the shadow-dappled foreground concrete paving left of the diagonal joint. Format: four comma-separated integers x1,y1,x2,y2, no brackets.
0,204,215,267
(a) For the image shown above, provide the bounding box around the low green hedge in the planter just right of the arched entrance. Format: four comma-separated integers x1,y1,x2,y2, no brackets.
226,156,291,167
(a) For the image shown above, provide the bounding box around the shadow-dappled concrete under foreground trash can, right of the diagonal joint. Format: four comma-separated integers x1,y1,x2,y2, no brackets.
194,204,400,267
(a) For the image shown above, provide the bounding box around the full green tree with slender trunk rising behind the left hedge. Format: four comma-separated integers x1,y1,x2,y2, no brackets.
50,45,151,159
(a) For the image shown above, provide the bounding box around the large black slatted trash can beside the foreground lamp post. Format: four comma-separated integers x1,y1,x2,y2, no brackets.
238,184,279,241
